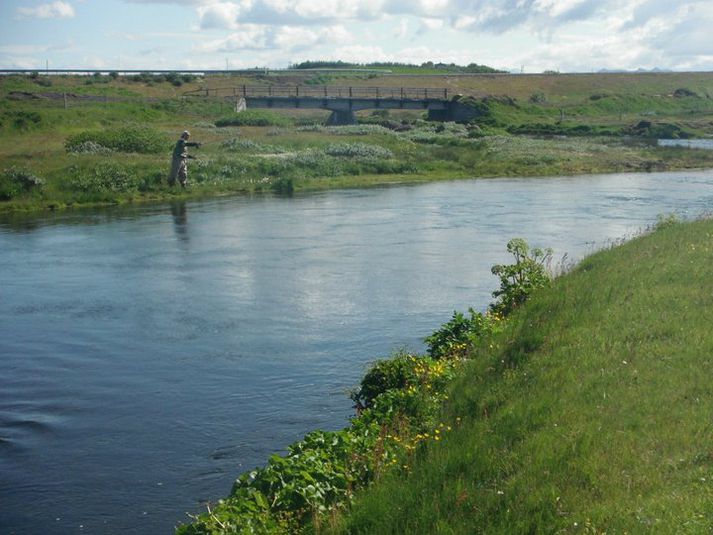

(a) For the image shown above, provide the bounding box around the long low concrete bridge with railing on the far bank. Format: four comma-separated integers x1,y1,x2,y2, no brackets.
183,85,476,125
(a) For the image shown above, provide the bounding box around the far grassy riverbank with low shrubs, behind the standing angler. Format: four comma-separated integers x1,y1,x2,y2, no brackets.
0,72,713,211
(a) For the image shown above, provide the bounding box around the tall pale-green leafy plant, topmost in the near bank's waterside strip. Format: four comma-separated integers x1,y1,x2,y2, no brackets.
490,238,552,316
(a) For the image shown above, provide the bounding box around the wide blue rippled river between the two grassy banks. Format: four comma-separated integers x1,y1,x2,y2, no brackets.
0,171,713,534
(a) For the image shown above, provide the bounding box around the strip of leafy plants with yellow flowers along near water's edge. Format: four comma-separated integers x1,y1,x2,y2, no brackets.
178,239,550,535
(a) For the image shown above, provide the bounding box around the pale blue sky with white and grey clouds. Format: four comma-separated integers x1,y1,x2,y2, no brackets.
0,0,713,73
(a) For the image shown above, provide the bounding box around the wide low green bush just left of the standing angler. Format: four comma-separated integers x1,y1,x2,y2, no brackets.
64,126,170,154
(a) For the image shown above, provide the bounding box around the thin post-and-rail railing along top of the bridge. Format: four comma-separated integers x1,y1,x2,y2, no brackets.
183,85,449,100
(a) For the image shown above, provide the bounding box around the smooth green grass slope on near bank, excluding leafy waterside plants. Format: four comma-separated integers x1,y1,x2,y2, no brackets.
334,220,713,534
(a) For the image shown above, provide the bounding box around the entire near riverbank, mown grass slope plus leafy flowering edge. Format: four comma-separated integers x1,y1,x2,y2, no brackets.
178,218,713,534
